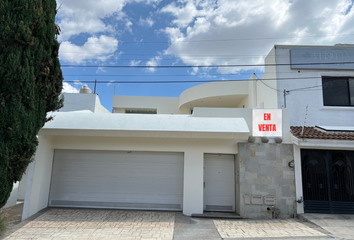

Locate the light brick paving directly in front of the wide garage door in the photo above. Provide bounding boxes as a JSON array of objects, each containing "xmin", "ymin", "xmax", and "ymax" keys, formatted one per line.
[{"xmin": 5, "ymin": 209, "xmax": 175, "ymax": 240}]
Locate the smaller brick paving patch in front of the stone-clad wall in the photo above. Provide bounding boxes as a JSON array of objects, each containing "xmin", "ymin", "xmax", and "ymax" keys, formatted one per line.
[{"xmin": 214, "ymin": 219, "xmax": 327, "ymax": 239}]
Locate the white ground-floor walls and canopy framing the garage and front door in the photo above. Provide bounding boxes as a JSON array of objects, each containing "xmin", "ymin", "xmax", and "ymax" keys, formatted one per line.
[{"xmin": 23, "ymin": 104, "xmax": 290, "ymax": 219}]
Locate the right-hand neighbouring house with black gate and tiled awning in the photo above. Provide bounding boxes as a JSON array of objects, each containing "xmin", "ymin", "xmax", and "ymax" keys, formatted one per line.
[{"xmin": 261, "ymin": 44, "xmax": 354, "ymax": 214}]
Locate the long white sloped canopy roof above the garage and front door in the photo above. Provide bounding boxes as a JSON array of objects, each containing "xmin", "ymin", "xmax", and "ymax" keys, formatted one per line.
[{"xmin": 39, "ymin": 112, "xmax": 250, "ymax": 139}]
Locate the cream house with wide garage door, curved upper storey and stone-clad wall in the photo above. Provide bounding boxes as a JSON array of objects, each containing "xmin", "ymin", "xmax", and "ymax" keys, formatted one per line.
[{"xmin": 23, "ymin": 76, "xmax": 295, "ymax": 219}]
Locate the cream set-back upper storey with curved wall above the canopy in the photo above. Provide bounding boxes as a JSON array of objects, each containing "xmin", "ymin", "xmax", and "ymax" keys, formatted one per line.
[{"xmin": 112, "ymin": 75, "xmax": 277, "ymax": 114}]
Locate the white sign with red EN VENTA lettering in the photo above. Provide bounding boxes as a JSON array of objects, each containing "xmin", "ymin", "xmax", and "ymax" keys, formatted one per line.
[{"xmin": 252, "ymin": 109, "xmax": 283, "ymax": 137}]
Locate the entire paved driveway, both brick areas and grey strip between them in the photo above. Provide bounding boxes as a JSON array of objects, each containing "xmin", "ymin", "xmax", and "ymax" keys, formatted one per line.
[{"xmin": 1, "ymin": 208, "xmax": 327, "ymax": 240}]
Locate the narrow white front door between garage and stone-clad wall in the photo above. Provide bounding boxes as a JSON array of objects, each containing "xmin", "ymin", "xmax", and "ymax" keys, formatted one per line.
[{"xmin": 204, "ymin": 154, "xmax": 235, "ymax": 212}]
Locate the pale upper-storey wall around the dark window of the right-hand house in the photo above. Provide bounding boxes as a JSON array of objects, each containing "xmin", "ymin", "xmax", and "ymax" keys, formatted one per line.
[{"xmin": 261, "ymin": 45, "xmax": 354, "ymax": 126}]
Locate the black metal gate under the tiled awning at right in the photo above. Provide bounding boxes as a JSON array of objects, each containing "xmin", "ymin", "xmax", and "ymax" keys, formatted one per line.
[{"xmin": 301, "ymin": 149, "xmax": 354, "ymax": 214}]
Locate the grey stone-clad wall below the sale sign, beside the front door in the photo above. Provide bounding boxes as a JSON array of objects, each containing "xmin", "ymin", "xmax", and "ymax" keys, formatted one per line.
[{"xmin": 236, "ymin": 143, "xmax": 296, "ymax": 218}]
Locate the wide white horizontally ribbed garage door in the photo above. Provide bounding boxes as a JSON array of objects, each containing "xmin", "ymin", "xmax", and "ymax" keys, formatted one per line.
[{"xmin": 49, "ymin": 150, "xmax": 183, "ymax": 210}]
